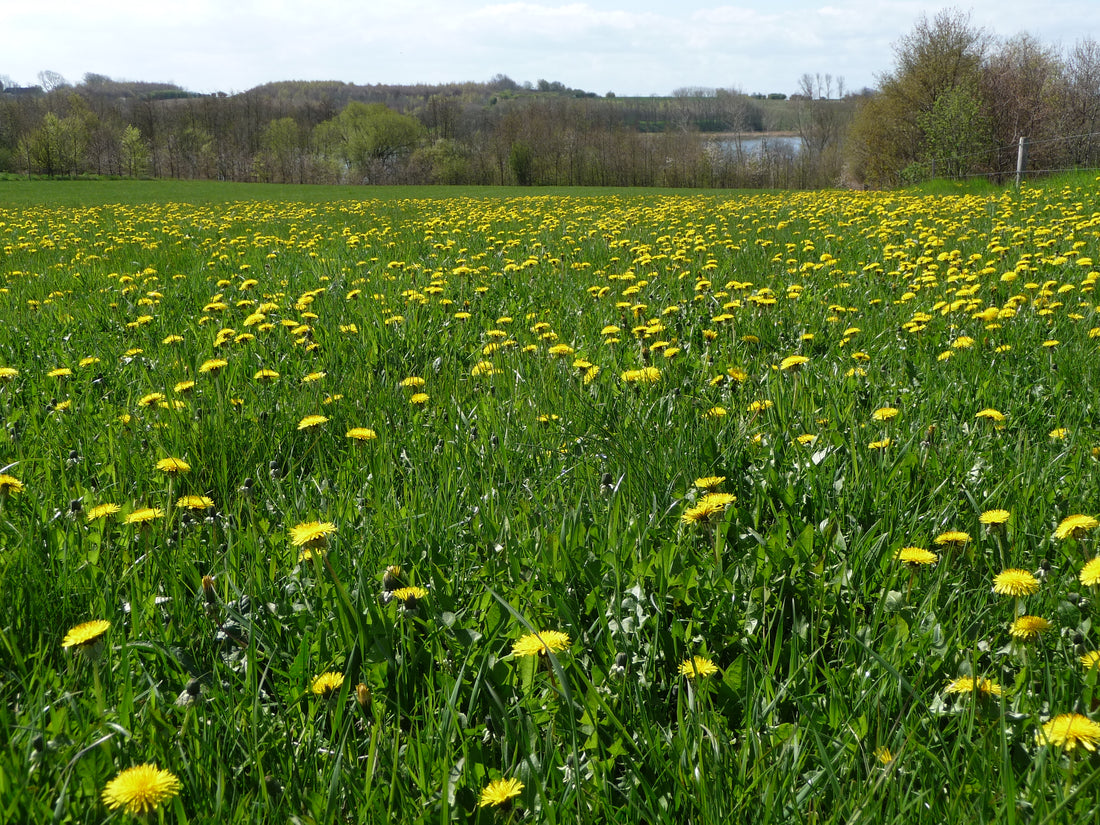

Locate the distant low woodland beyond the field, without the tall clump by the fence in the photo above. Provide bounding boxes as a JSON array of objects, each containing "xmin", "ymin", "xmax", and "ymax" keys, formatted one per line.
[{"xmin": 0, "ymin": 73, "xmax": 850, "ymax": 187}]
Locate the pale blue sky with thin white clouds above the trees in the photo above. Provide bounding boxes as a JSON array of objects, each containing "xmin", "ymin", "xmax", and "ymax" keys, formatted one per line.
[{"xmin": 0, "ymin": 0, "xmax": 1100, "ymax": 96}]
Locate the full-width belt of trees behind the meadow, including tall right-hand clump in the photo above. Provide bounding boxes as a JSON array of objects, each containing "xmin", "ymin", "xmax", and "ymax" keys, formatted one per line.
[{"xmin": 0, "ymin": 9, "xmax": 1100, "ymax": 188}]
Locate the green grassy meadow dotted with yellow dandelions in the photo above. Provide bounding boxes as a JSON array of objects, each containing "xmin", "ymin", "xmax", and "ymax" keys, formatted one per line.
[{"xmin": 0, "ymin": 177, "xmax": 1100, "ymax": 823}]
